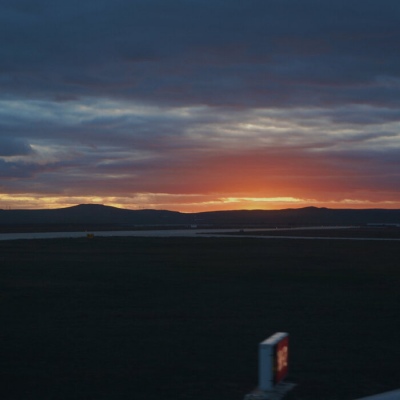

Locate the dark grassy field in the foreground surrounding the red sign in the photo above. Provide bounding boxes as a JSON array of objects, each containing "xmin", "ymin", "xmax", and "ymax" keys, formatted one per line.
[{"xmin": 0, "ymin": 238, "xmax": 400, "ymax": 400}]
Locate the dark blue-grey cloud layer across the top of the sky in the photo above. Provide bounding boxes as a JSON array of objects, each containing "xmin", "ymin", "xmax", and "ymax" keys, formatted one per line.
[{"xmin": 0, "ymin": 0, "xmax": 400, "ymax": 107}]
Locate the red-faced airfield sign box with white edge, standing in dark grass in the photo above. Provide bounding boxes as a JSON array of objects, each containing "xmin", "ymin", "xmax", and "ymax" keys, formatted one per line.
[{"xmin": 259, "ymin": 332, "xmax": 289, "ymax": 391}]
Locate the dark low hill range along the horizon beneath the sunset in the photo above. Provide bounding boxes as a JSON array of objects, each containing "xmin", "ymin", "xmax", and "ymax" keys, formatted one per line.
[{"xmin": 0, "ymin": 204, "xmax": 400, "ymax": 230}]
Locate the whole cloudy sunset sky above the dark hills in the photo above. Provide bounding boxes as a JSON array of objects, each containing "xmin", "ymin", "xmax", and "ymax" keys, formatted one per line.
[{"xmin": 0, "ymin": 0, "xmax": 400, "ymax": 212}]
